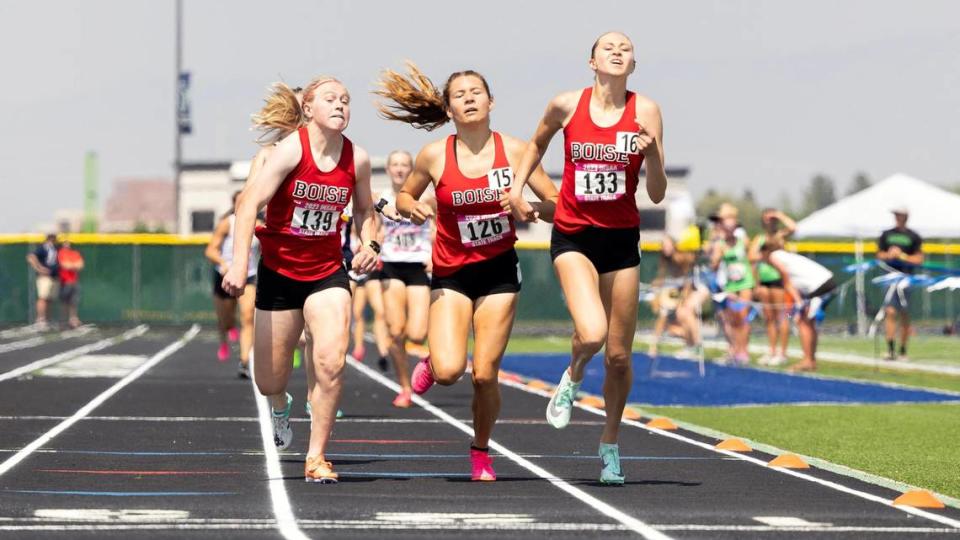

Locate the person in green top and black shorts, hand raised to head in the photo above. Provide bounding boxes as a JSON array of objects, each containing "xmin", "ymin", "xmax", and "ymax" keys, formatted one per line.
[{"xmin": 750, "ymin": 208, "xmax": 797, "ymax": 366}]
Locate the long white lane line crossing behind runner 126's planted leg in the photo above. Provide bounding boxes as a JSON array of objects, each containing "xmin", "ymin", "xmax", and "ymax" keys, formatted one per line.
[{"xmin": 347, "ymin": 356, "xmax": 670, "ymax": 540}]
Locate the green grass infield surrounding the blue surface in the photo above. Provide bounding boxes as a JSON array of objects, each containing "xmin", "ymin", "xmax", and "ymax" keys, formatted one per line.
[{"xmin": 498, "ymin": 336, "xmax": 960, "ymax": 498}]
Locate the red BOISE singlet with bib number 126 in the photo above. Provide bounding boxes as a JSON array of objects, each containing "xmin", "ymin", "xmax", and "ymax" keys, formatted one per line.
[{"xmin": 433, "ymin": 131, "xmax": 517, "ymax": 277}]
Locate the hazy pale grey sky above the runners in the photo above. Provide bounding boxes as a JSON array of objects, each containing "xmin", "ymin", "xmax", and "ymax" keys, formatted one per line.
[{"xmin": 0, "ymin": 0, "xmax": 960, "ymax": 232}]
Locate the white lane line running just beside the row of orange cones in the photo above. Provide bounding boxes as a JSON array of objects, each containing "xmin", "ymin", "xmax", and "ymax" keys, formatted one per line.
[{"xmin": 500, "ymin": 381, "xmax": 960, "ymax": 529}]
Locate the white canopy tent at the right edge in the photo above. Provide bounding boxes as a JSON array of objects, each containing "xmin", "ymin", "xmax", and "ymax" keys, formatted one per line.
[{"xmin": 795, "ymin": 174, "xmax": 960, "ymax": 334}]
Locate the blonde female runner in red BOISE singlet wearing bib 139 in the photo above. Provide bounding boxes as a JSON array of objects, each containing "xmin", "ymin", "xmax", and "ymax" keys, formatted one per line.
[{"xmin": 223, "ymin": 77, "xmax": 379, "ymax": 483}]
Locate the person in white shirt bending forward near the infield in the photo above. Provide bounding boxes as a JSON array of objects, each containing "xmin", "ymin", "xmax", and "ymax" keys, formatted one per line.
[{"xmin": 760, "ymin": 243, "xmax": 837, "ymax": 371}]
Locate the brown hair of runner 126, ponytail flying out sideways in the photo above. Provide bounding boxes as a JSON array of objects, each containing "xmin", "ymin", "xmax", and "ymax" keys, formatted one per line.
[{"xmin": 373, "ymin": 61, "xmax": 493, "ymax": 131}]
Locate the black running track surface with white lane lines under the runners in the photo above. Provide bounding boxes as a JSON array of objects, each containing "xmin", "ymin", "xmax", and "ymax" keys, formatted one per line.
[{"xmin": 0, "ymin": 328, "xmax": 960, "ymax": 540}]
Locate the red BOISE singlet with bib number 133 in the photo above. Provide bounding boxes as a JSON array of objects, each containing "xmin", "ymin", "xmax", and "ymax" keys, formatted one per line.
[{"xmin": 553, "ymin": 88, "xmax": 643, "ymax": 234}]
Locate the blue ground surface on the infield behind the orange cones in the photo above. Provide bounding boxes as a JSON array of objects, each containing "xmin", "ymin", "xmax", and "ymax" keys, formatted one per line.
[{"xmin": 501, "ymin": 353, "xmax": 960, "ymax": 406}]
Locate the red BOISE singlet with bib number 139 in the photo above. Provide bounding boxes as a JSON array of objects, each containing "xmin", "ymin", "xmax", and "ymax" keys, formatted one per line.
[{"xmin": 257, "ymin": 127, "xmax": 357, "ymax": 281}]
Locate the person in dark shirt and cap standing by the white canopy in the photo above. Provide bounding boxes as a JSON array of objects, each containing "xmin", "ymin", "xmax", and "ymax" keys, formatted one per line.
[{"xmin": 877, "ymin": 206, "xmax": 924, "ymax": 360}]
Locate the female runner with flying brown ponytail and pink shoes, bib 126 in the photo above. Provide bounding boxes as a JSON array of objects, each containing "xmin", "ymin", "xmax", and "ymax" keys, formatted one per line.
[{"xmin": 377, "ymin": 64, "xmax": 557, "ymax": 481}]
